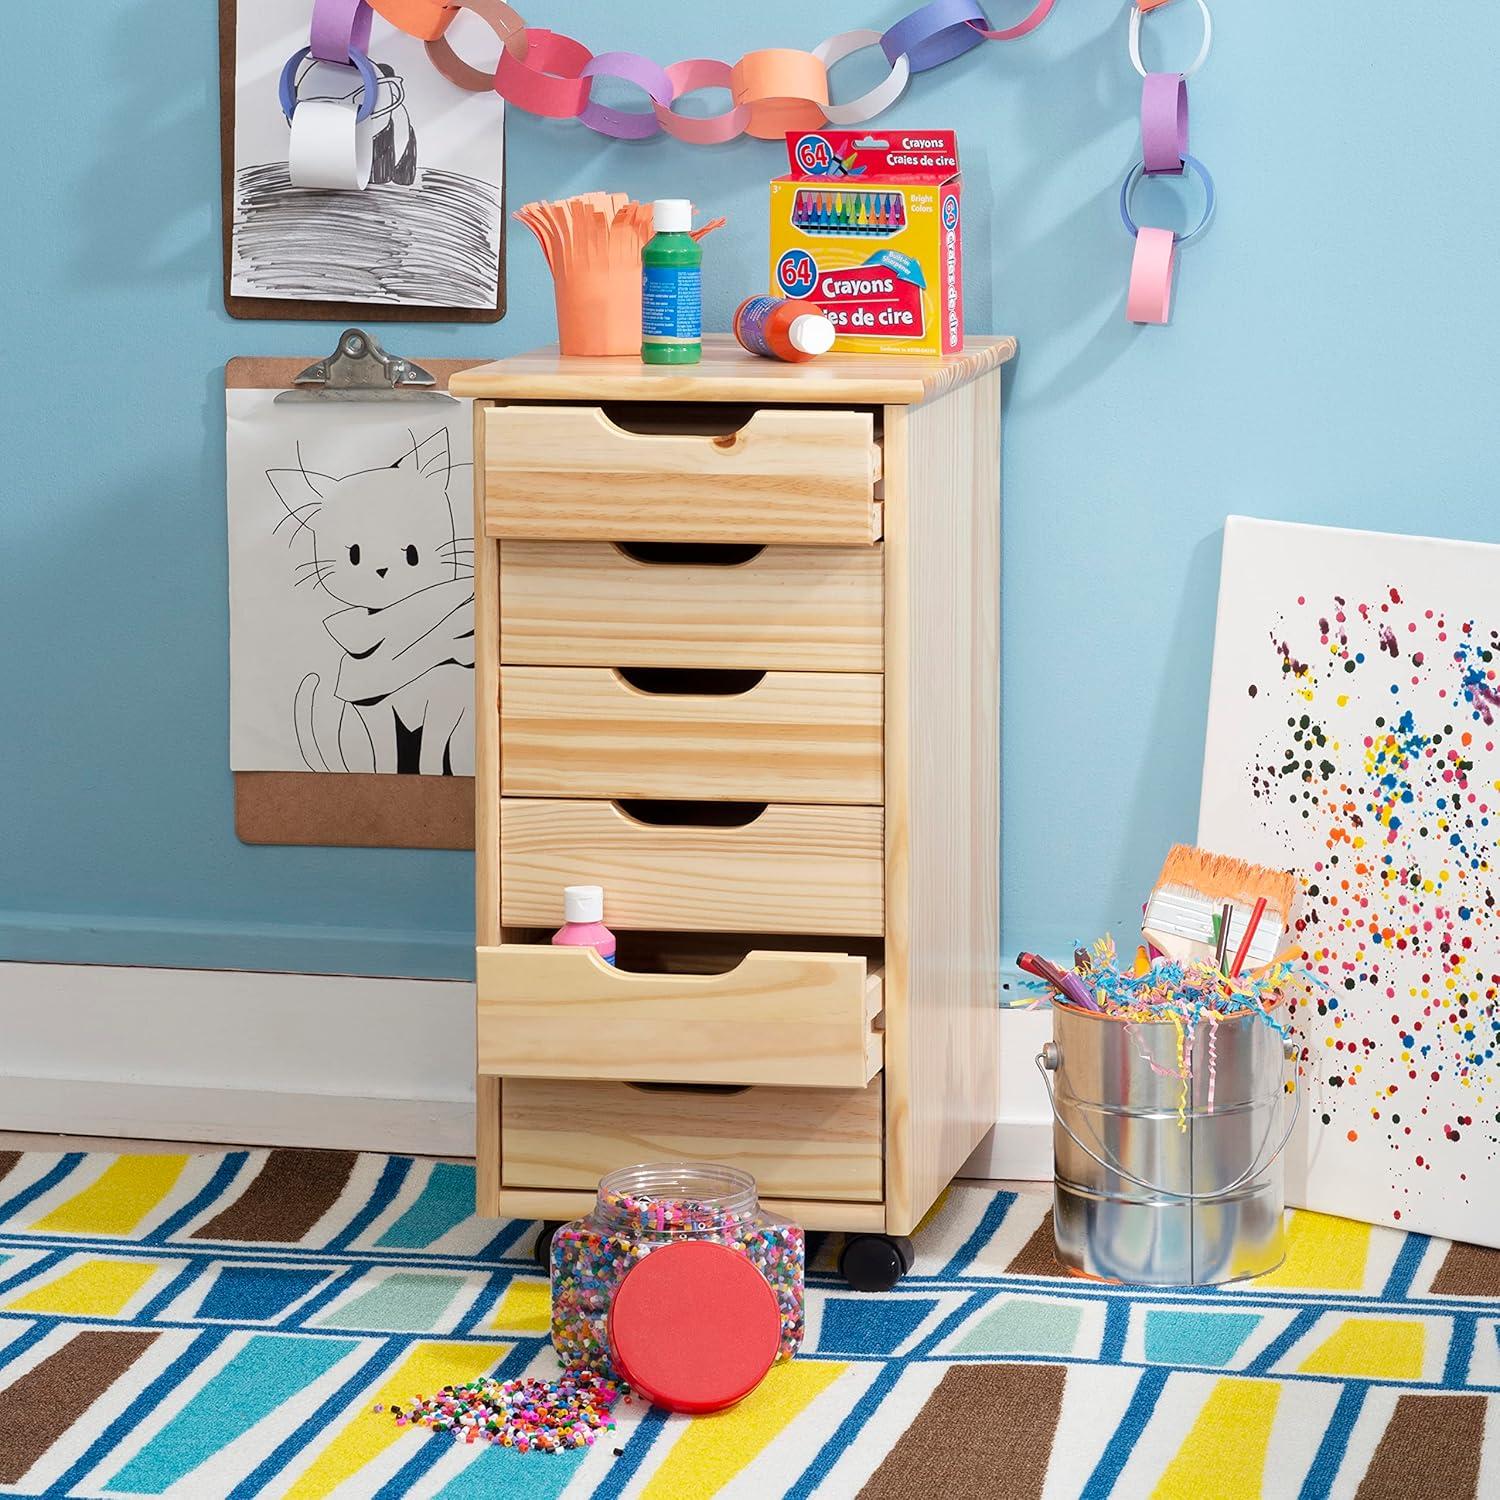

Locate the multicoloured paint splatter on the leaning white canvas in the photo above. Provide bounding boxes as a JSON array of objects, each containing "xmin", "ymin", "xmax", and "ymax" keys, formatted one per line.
[{"xmin": 1247, "ymin": 584, "xmax": 1500, "ymax": 1220}]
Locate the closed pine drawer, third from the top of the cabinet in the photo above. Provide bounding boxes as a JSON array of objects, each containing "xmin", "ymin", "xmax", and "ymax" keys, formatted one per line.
[{"xmin": 500, "ymin": 666, "xmax": 885, "ymax": 806}]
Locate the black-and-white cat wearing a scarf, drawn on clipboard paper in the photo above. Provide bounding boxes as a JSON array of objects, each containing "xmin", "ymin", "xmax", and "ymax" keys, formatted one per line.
[{"xmin": 266, "ymin": 428, "xmax": 474, "ymax": 776}]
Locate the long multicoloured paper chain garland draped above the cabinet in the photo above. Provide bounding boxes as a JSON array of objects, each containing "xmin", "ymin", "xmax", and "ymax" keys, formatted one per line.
[{"xmin": 281, "ymin": 0, "xmax": 1056, "ymax": 147}]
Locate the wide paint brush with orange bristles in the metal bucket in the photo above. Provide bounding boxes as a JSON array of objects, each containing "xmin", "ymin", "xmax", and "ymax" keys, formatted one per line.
[{"xmin": 1140, "ymin": 845, "xmax": 1298, "ymax": 971}]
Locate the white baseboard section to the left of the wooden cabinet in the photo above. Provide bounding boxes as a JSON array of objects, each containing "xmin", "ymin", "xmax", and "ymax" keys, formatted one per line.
[{"xmin": 0, "ymin": 963, "xmax": 474, "ymax": 1157}]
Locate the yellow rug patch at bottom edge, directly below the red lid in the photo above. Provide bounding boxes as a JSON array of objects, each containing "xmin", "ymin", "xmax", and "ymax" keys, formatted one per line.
[{"xmin": 641, "ymin": 1359, "xmax": 849, "ymax": 1500}]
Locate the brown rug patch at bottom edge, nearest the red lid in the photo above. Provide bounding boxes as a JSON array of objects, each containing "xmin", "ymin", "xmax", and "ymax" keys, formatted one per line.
[{"xmin": 860, "ymin": 1365, "xmax": 1068, "ymax": 1500}]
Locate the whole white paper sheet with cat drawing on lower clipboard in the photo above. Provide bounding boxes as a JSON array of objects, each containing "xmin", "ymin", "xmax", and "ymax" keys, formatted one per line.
[{"xmin": 225, "ymin": 390, "xmax": 474, "ymax": 776}]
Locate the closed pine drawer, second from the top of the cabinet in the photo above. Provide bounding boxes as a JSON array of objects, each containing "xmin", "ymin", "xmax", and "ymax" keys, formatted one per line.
[{"xmin": 500, "ymin": 542, "xmax": 884, "ymax": 672}]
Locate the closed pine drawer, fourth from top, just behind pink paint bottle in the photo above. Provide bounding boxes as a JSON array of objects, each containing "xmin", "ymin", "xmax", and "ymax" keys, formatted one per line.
[{"xmin": 500, "ymin": 797, "xmax": 885, "ymax": 936}]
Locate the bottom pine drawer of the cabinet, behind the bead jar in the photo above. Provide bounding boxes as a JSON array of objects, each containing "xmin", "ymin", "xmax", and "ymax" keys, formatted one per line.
[{"xmin": 500, "ymin": 1079, "xmax": 882, "ymax": 1203}]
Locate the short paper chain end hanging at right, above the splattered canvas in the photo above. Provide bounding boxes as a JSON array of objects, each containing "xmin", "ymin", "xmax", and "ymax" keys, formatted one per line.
[{"xmin": 1121, "ymin": 0, "xmax": 1214, "ymax": 324}]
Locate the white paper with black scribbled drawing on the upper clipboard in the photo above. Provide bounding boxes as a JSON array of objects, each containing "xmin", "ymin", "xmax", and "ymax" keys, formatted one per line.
[{"xmin": 230, "ymin": 0, "xmax": 506, "ymax": 308}]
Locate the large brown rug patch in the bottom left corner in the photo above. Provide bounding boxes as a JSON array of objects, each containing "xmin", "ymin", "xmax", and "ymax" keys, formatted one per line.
[{"xmin": 0, "ymin": 1329, "xmax": 158, "ymax": 1485}]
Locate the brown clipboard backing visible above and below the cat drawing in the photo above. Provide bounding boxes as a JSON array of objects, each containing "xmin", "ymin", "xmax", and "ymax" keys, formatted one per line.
[{"xmin": 224, "ymin": 359, "xmax": 483, "ymax": 849}]
